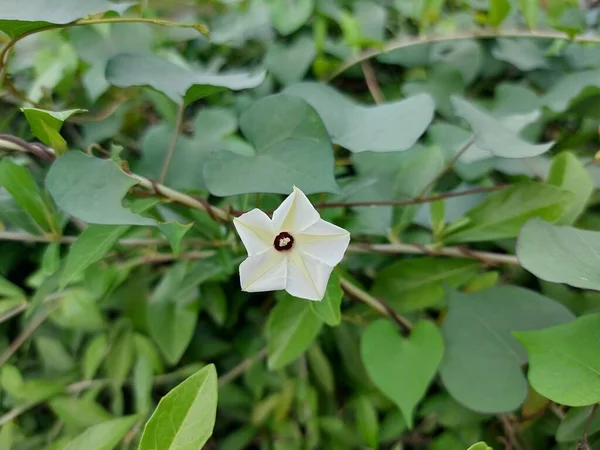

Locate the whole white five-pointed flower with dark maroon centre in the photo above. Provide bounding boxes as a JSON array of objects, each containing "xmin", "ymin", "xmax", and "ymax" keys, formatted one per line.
[{"xmin": 233, "ymin": 186, "xmax": 350, "ymax": 300}]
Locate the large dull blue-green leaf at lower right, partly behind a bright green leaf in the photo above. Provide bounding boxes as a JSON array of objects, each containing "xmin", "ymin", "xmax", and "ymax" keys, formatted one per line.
[{"xmin": 440, "ymin": 286, "xmax": 573, "ymax": 413}]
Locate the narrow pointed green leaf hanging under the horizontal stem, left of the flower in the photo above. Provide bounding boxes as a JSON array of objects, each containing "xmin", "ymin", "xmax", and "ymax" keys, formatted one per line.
[{"xmin": 59, "ymin": 225, "xmax": 129, "ymax": 289}]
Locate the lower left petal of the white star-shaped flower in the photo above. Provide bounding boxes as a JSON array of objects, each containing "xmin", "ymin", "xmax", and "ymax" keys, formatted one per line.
[{"xmin": 240, "ymin": 248, "xmax": 288, "ymax": 292}]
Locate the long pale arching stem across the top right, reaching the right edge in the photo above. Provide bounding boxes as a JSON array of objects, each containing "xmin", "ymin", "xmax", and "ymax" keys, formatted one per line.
[{"xmin": 324, "ymin": 30, "xmax": 600, "ymax": 81}]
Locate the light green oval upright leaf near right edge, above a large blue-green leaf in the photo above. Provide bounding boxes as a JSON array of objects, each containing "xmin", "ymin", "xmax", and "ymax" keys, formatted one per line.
[{"xmin": 547, "ymin": 152, "xmax": 595, "ymax": 225}]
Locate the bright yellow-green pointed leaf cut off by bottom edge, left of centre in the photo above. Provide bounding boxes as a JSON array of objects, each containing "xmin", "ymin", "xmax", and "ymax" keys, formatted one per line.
[{"xmin": 139, "ymin": 364, "xmax": 217, "ymax": 450}]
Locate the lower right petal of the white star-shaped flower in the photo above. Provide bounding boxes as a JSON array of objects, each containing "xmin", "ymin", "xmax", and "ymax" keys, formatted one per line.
[{"xmin": 285, "ymin": 251, "xmax": 333, "ymax": 300}]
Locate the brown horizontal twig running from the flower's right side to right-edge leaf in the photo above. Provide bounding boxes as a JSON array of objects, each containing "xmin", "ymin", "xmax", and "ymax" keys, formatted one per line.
[{"xmin": 348, "ymin": 243, "xmax": 520, "ymax": 266}]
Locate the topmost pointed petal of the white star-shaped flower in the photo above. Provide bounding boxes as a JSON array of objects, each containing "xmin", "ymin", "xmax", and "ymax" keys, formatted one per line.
[{"xmin": 273, "ymin": 186, "xmax": 320, "ymax": 236}]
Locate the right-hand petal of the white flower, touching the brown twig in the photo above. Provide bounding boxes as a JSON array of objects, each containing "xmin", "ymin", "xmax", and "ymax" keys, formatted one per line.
[{"xmin": 295, "ymin": 219, "xmax": 350, "ymax": 267}]
